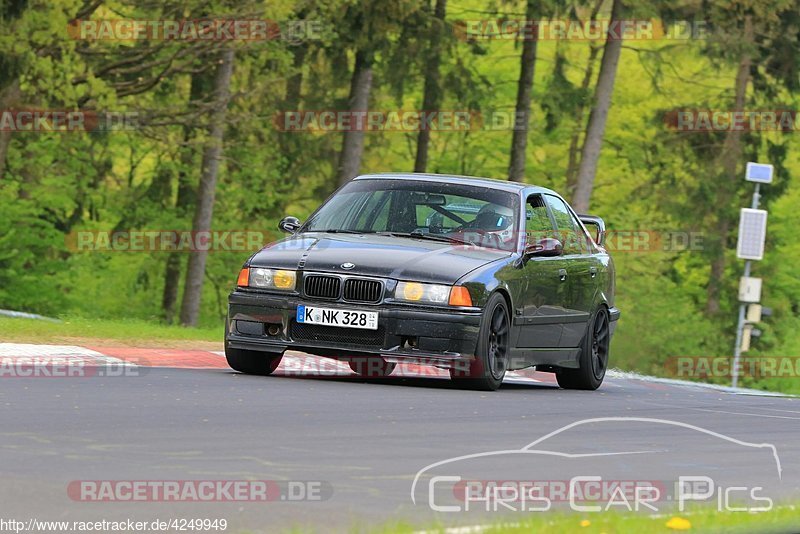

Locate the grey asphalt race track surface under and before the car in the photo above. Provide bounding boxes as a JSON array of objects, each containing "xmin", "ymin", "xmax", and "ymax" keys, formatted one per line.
[{"xmin": 0, "ymin": 351, "xmax": 800, "ymax": 532}]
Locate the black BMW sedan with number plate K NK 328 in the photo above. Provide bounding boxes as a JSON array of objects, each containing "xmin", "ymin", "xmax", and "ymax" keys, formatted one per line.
[{"xmin": 225, "ymin": 174, "xmax": 619, "ymax": 390}]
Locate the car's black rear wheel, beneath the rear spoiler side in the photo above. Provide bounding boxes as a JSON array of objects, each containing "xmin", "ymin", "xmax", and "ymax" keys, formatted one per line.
[{"xmin": 556, "ymin": 306, "xmax": 611, "ymax": 390}]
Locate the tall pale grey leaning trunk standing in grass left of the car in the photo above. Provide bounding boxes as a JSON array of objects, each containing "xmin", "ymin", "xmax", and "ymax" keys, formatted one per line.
[{"xmin": 181, "ymin": 49, "xmax": 234, "ymax": 326}]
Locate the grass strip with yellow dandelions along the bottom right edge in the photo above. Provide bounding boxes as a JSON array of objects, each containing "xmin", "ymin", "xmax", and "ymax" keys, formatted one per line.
[{"xmin": 369, "ymin": 505, "xmax": 800, "ymax": 534}]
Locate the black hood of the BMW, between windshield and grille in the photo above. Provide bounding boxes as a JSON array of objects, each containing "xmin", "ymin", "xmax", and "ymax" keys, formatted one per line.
[{"xmin": 250, "ymin": 233, "xmax": 511, "ymax": 284}]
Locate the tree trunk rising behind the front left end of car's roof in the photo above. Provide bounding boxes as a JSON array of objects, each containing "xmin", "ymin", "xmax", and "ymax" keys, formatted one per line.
[{"xmin": 338, "ymin": 50, "xmax": 372, "ymax": 185}]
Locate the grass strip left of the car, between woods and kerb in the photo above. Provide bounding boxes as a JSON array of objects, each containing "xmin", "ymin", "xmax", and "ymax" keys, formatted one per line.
[{"xmin": 0, "ymin": 317, "xmax": 224, "ymax": 345}]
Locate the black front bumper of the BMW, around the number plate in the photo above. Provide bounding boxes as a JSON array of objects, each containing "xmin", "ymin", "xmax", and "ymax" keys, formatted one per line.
[{"xmin": 225, "ymin": 290, "xmax": 481, "ymax": 367}]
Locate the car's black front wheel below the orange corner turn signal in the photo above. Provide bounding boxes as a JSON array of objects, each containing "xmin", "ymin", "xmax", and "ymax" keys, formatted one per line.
[{"xmin": 450, "ymin": 293, "xmax": 511, "ymax": 391}]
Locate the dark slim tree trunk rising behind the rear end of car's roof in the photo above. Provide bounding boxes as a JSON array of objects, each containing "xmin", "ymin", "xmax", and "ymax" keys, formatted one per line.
[{"xmin": 508, "ymin": 0, "xmax": 540, "ymax": 182}]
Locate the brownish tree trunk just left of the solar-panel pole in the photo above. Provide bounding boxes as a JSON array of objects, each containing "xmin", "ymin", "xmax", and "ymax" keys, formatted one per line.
[{"xmin": 706, "ymin": 15, "xmax": 753, "ymax": 315}]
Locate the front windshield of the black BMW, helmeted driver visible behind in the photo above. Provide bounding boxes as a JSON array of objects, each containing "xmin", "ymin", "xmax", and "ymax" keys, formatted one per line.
[{"xmin": 303, "ymin": 179, "xmax": 519, "ymax": 250}]
